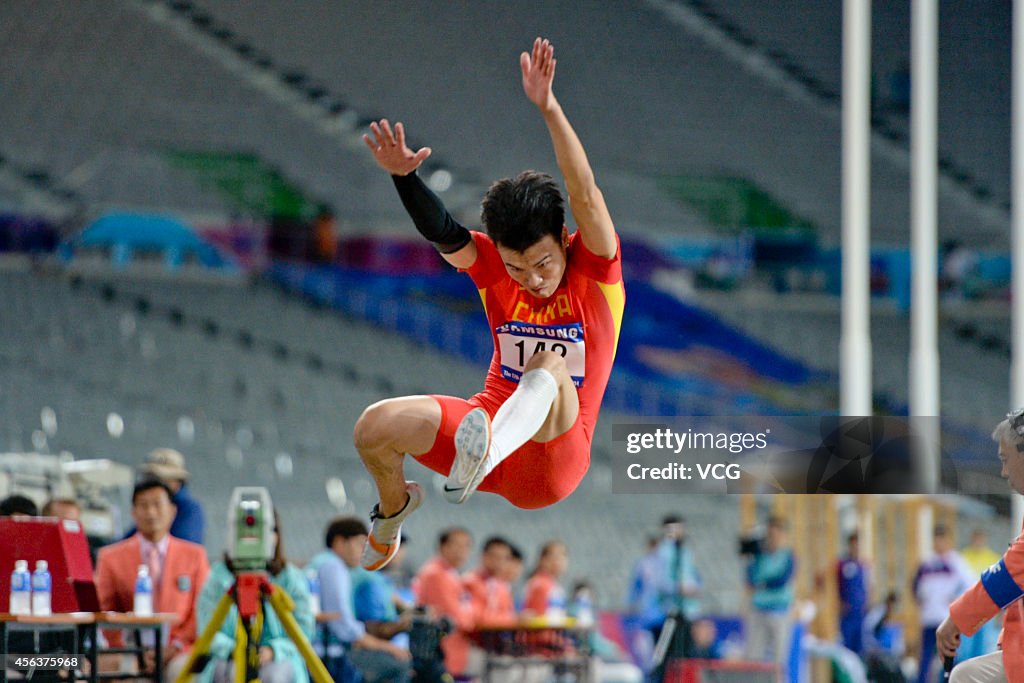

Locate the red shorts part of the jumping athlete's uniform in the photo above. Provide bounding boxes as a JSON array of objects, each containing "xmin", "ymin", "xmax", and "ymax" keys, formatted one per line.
[{"xmin": 416, "ymin": 395, "xmax": 590, "ymax": 510}]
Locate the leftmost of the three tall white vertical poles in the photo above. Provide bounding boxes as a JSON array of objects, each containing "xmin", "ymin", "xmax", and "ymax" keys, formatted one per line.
[{"xmin": 840, "ymin": 0, "xmax": 871, "ymax": 416}]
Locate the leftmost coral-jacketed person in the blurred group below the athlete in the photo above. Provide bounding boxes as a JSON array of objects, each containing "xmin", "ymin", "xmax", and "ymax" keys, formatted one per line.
[{"xmin": 413, "ymin": 527, "xmax": 476, "ymax": 676}]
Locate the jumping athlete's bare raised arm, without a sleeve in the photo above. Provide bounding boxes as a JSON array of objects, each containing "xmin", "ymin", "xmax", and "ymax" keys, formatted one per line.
[{"xmin": 519, "ymin": 38, "xmax": 616, "ymax": 258}]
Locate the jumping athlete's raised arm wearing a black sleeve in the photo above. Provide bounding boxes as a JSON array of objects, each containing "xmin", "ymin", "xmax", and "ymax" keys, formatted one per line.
[{"xmin": 362, "ymin": 119, "xmax": 476, "ymax": 268}]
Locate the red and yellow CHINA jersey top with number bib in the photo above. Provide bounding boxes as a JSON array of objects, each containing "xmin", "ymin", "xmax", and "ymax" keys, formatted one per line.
[{"xmin": 466, "ymin": 231, "xmax": 626, "ymax": 442}]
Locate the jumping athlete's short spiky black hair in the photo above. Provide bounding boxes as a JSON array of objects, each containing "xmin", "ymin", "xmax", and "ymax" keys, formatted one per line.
[{"xmin": 480, "ymin": 171, "xmax": 565, "ymax": 253}]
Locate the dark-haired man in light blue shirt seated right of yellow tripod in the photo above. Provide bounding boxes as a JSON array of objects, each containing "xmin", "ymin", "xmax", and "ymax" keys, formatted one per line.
[{"xmin": 307, "ymin": 517, "xmax": 410, "ymax": 683}]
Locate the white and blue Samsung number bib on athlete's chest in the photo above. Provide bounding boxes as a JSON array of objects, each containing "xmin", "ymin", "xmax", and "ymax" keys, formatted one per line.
[{"xmin": 495, "ymin": 323, "xmax": 587, "ymax": 387}]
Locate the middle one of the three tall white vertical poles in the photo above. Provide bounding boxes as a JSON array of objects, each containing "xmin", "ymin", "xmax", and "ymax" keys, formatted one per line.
[{"xmin": 909, "ymin": 0, "xmax": 941, "ymax": 493}]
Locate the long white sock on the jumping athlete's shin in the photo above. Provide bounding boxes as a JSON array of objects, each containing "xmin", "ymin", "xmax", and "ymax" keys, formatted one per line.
[{"xmin": 483, "ymin": 368, "xmax": 558, "ymax": 472}]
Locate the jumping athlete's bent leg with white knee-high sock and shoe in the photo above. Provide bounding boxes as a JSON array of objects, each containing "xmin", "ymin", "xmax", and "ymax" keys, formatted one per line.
[{"xmin": 444, "ymin": 351, "xmax": 580, "ymax": 503}]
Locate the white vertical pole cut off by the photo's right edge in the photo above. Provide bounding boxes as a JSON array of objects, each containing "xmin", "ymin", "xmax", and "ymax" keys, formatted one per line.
[{"xmin": 1010, "ymin": 0, "xmax": 1024, "ymax": 528}]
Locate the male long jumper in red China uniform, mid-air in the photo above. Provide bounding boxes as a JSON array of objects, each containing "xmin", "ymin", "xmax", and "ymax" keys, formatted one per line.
[{"xmin": 355, "ymin": 38, "xmax": 626, "ymax": 569}]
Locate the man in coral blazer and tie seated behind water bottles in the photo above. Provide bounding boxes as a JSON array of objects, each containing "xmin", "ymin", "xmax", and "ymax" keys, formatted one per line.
[{"xmin": 96, "ymin": 479, "xmax": 210, "ymax": 680}]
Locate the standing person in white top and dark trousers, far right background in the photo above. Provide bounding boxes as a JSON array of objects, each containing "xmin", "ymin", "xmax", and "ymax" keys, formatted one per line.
[{"xmin": 913, "ymin": 524, "xmax": 975, "ymax": 683}]
